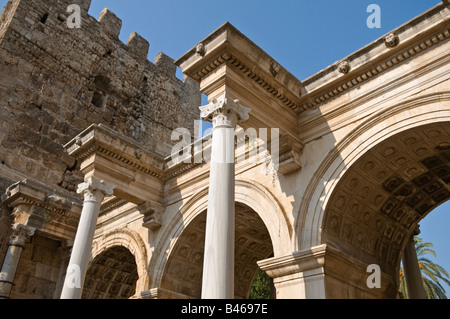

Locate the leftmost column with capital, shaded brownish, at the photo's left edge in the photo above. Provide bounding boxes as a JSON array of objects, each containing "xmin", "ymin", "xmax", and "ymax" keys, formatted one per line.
[{"xmin": 0, "ymin": 224, "xmax": 35, "ymax": 299}]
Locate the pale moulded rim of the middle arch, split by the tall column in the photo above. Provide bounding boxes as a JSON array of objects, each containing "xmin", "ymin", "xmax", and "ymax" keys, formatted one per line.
[{"xmin": 149, "ymin": 180, "xmax": 292, "ymax": 297}]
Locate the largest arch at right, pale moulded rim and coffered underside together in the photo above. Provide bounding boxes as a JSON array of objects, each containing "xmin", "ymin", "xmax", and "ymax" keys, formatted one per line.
[{"xmin": 297, "ymin": 92, "xmax": 450, "ymax": 297}]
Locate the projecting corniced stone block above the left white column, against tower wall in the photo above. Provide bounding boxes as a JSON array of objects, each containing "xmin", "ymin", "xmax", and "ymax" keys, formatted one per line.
[{"xmin": 65, "ymin": 124, "xmax": 165, "ymax": 205}]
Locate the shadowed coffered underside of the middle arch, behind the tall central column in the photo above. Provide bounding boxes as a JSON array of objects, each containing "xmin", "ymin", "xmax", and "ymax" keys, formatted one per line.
[{"xmin": 161, "ymin": 203, "xmax": 273, "ymax": 299}]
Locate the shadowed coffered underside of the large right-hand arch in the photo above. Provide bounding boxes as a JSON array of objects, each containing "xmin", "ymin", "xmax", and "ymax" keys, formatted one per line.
[{"xmin": 322, "ymin": 122, "xmax": 450, "ymax": 276}]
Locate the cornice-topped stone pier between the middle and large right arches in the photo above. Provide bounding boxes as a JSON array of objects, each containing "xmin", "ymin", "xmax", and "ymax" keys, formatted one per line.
[{"xmin": 258, "ymin": 245, "xmax": 397, "ymax": 299}]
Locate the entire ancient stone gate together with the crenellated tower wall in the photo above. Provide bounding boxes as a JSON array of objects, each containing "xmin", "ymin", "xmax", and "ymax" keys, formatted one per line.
[{"xmin": 0, "ymin": 0, "xmax": 450, "ymax": 299}]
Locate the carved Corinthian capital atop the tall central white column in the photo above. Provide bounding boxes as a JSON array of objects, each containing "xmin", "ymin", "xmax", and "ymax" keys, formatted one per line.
[{"xmin": 200, "ymin": 94, "xmax": 251, "ymax": 128}]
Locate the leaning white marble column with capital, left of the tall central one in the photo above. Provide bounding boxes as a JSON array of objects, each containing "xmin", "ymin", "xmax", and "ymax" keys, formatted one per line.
[{"xmin": 61, "ymin": 177, "xmax": 114, "ymax": 299}]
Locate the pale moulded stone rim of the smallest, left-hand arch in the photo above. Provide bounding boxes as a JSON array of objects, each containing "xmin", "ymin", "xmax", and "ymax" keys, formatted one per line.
[{"xmin": 90, "ymin": 228, "xmax": 148, "ymax": 292}]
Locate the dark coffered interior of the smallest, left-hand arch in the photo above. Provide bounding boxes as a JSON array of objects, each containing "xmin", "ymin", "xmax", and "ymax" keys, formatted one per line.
[{"xmin": 82, "ymin": 246, "xmax": 139, "ymax": 299}]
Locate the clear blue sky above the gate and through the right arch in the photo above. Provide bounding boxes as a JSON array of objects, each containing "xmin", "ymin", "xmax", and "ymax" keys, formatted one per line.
[{"xmin": 0, "ymin": 0, "xmax": 450, "ymax": 296}]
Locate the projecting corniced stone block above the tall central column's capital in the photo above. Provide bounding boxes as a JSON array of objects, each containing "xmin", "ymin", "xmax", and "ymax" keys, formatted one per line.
[{"xmin": 175, "ymin": 22, "xmax": 304, "ymax": 139}]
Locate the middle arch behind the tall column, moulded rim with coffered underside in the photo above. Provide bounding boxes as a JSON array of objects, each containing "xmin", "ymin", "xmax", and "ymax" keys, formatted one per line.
[{"xmin": 148, "ymin": 179, "xmax": 292, "ymax": 298}]
